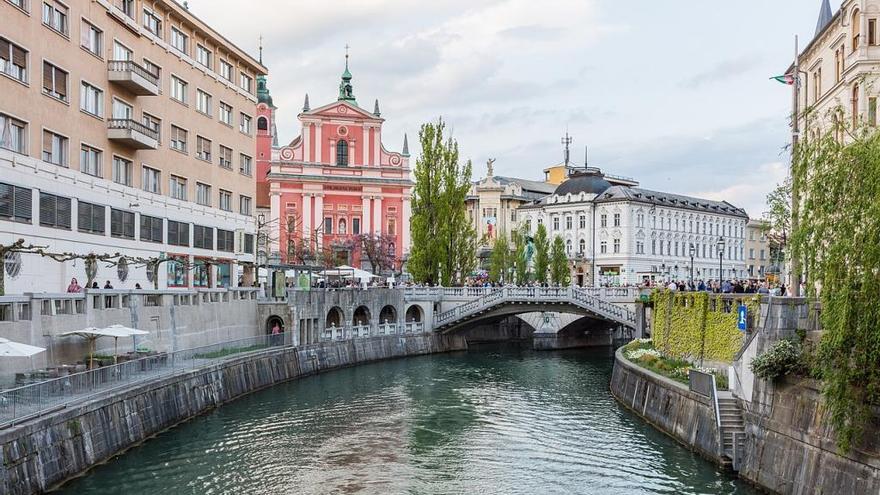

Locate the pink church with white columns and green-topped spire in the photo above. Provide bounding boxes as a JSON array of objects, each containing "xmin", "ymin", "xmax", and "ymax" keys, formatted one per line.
[{"xmin": 256, "ymin": 55, "xmax": 413, "ymax": 270}]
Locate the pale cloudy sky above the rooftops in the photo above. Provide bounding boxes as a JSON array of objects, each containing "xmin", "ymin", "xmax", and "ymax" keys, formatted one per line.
[{"xmin": 189, "ymin": 0, "xmax": 828, "ymax": 216}]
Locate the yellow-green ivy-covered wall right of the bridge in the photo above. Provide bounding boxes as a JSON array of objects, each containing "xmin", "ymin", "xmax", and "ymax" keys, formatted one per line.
[{"xmin": 651, "ymin": 290, "xmax": 760, "ymax": 362}]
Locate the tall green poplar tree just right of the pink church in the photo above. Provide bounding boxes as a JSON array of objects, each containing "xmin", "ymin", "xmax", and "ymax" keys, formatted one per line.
[{"xmin": 407, "ymin": 119, "xmax": 476, "ymax": 285}]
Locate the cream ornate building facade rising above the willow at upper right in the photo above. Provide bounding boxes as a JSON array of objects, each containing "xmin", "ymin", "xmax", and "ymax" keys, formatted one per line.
[{"xmin": 788, "ymin": 0, "xmax": 880, "ymax": 134}]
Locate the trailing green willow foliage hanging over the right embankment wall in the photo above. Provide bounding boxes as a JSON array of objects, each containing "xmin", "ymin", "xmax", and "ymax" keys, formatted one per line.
[{"xmin": 791, "ymin": 113, "xmax": 880, "ymax": 452}]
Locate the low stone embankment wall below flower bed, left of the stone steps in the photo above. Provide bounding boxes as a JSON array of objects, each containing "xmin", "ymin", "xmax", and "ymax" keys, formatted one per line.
[{"xmin": 611, "ymin": 348, "xmax": 723, "ymax": 464}]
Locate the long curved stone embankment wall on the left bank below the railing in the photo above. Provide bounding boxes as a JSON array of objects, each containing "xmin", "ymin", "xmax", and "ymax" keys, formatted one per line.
[{"xmin": 0, "ymin": 334, "xmax": 467, "ymax": 495}]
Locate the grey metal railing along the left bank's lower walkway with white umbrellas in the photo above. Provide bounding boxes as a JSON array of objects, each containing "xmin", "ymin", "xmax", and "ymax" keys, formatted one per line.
[{"xmin": 0, "ymin": 334, "xmax": 287, "ymax": 427}]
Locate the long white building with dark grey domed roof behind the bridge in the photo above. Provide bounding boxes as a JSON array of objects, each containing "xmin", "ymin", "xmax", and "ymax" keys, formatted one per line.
[{"xmin": 518, "ymin": 168, "xmax": 748, "ymax": 285}]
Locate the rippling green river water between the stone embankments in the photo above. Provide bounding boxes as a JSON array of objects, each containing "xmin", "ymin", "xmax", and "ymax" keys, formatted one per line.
[{"xmin": 61, "ymin": 347, "xmax": 756, "ymax": 495}]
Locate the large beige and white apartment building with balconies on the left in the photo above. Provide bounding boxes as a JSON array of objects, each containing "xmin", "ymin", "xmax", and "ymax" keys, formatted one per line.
[{"xmin": 0, "ymin": 0, "xmax": 266, "ymax": 293}]
